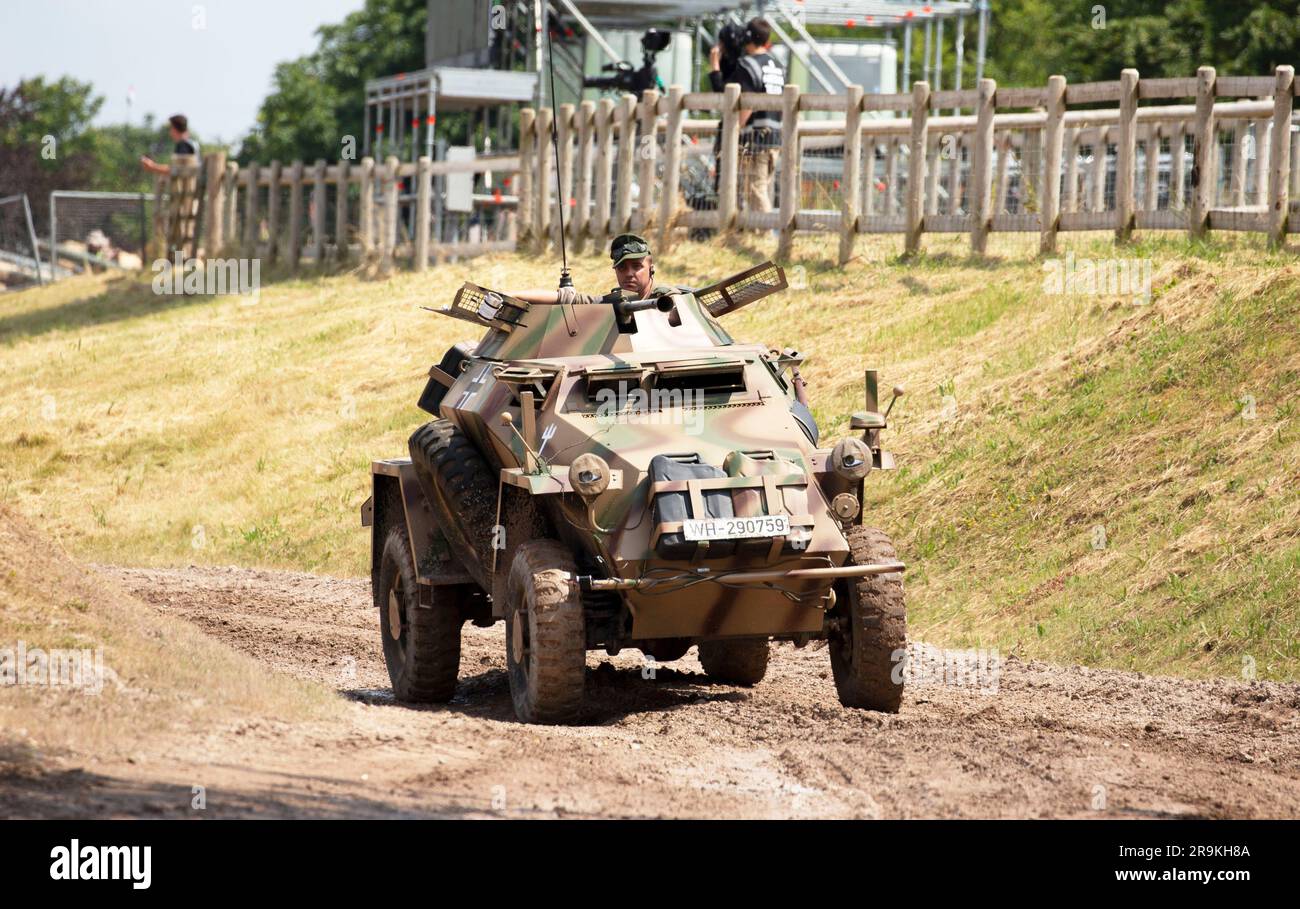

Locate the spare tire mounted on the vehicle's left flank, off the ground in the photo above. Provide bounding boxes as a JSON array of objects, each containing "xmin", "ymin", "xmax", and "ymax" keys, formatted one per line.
[{"xmin": 410, "ymin": 420, "xmax": 497, "ymax": 593}]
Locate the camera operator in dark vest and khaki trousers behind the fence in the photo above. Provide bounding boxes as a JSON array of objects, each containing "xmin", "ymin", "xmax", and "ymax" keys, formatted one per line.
[{"xmin": 735, "ymin": 18, "xmax": 785, "ymax": 212}]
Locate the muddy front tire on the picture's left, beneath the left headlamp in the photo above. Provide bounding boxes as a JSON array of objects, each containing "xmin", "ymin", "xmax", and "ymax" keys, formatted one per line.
[{"xmin": 506, "ymin": 540, "xmax": 586, "ymax": 723}]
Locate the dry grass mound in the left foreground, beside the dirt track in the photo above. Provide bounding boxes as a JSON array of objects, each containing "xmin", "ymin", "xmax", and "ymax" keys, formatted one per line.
[{"xmin": 0, "ymin": 506, "xmax": 333, "ymax": 765}]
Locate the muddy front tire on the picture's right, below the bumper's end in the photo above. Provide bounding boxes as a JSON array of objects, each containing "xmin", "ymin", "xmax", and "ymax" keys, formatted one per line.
[{"xmin": 828, "ymin": 527, "xmax": 907, "ymax": 713}]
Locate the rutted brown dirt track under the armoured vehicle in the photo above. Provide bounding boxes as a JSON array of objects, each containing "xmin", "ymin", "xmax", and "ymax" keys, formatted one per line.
[{"xmin": 13, "ymin": 568, "xmax": 1300, "ymax": 818}]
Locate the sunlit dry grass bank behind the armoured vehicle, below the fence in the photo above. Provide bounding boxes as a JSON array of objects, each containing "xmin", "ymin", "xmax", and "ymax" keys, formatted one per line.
[{"xmin": 0, "ymin": 237, "xmax": 1300, "ymax": 678}]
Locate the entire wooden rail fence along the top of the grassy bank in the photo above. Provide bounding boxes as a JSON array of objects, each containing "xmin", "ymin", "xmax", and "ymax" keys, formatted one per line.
[{"xmin": 159, "ymin": 66, "xmax": 1300, "ymax": 270}]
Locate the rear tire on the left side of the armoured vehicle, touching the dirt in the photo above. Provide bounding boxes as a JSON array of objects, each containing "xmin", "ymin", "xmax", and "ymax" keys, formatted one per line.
[{"xmin": 374, "ymin": 527, "xmax": 464, "ymax": 704}]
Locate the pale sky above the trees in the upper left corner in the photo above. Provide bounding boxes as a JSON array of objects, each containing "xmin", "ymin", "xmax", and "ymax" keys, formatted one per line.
[{"xmin": 0, "ymin": 0, "xmax": 364, "ymax": 142}]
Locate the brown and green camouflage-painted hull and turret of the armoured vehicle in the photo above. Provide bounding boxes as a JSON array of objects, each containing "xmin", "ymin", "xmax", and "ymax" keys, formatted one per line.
[{"xmin": 374, "ymin": 270, "xmax": 892, "ymax": 646}]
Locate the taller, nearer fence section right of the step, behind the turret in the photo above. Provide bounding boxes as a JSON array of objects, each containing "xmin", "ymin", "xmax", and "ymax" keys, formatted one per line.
[{"xmin": 519, "ymin": 66, "xmax": 1300, "ymax": 261}]
